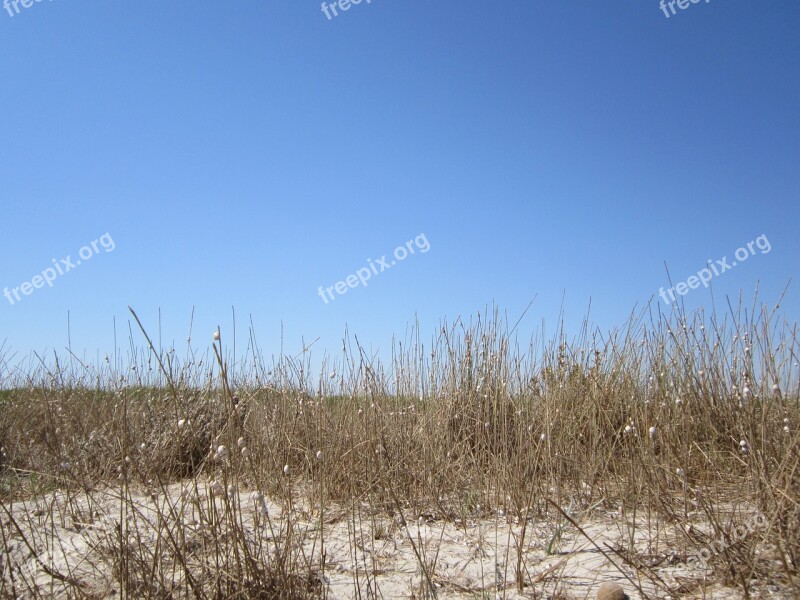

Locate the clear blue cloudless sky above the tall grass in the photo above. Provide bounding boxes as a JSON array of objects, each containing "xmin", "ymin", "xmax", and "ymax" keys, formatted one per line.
[{"xmin": 0, "ymin": 0, "xmax": 800, "ymax": 372}]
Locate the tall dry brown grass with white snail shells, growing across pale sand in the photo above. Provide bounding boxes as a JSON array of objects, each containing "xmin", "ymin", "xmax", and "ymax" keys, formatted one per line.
[{"xmin": 0, "ymin": 307, "xmax": 800, "ymax": 598}]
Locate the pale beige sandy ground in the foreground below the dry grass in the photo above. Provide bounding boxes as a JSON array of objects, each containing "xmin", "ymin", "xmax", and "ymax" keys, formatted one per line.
[{"xmin": 0, "ymin": 484, "xmax": 793, "ymax": 599}]
